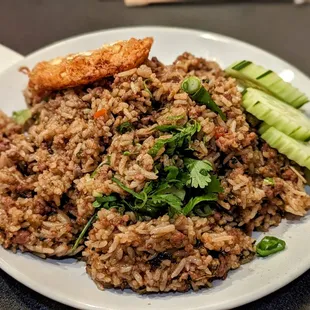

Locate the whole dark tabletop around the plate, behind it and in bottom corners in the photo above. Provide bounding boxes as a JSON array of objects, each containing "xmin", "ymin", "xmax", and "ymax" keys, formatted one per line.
[{"xmin": 0, "ymin": 0, "xmax": 310, "ymax": 310}]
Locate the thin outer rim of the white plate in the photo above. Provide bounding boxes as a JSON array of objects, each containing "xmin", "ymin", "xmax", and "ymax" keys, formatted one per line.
[{"xmin": 0, "ymin": 25, "xmax": 310, "ymax": 310}]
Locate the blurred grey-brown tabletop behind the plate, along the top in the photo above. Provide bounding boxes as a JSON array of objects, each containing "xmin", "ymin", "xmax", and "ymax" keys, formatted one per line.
[{"xmin": 0, "ymin": 0, "xmax": 310, "ymax": 74}]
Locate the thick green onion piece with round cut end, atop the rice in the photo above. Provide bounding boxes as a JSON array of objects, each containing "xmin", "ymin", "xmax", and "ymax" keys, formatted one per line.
[{"xmin": 181, "ymin": 76, "xmax": 226, "ymax": 121}]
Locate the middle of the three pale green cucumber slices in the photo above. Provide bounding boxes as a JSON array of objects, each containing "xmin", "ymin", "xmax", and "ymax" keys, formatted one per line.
[{"xmin": 243, "ymin": 88, "xmax": 310, "ymax": 141}]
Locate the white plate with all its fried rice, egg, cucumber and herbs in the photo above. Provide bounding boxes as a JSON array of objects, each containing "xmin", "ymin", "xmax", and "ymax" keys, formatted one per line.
[{"xmin": 0, "ymin": 27, "xmax": 310, "ymax": 310}]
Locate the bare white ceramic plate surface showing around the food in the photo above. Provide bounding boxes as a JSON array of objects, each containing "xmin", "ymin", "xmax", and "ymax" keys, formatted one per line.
[{"xmin": 0, "ymin": 27, "xmax": 310, "ymax": 310}]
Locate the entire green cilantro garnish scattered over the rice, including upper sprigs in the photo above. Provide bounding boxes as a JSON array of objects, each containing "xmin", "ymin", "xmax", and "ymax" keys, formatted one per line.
[{"xmin": 74, "ymin": 121, "xmax": 223, "ymax": 249}]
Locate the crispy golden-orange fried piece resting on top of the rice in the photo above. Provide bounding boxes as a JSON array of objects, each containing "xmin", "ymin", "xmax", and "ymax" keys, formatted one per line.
[{"xmin": 28, "ymin": 38, "xmax": 153, "ymax": 94}]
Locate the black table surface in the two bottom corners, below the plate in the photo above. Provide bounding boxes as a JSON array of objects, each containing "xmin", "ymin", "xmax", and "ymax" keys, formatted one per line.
[{"xmin": 0, "ymin": 270, "xmax": 310, "ymax": 310}]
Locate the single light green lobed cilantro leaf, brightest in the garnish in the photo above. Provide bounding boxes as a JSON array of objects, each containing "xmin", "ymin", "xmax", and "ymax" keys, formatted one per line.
[{"xmin": 184, "ymin": 158, "xmax": 212, "ymax": 188}]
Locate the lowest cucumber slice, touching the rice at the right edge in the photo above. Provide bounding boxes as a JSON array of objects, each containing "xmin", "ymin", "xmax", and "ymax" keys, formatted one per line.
[{"xmin": 259, "ymin": 125, "xmax": 310, "ymax": 169}]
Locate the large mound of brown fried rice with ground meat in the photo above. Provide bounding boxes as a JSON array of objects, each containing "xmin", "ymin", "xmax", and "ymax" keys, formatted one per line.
[{"xmin": 0, "ymin": 46, "xmax": 310, "ymax": 293}]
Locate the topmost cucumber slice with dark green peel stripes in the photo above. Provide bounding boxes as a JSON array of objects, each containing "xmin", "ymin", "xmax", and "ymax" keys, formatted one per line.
[{"xmin": 225, "ymin": 60, "xmax": 309, "ymax": 108}]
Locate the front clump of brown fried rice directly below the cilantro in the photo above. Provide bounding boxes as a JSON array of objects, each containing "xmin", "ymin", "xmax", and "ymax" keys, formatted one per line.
[{"xmin": 83, "ymin": 210, "xmax": 254, "ymax": 293}]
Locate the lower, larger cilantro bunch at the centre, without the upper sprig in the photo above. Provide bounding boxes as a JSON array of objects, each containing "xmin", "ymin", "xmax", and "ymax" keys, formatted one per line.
[{"xmin": 93, "ymin": 158, "xmax": 222, "ymax": 218}]
